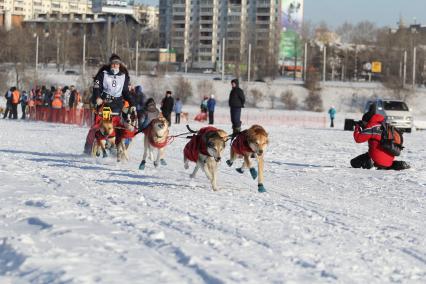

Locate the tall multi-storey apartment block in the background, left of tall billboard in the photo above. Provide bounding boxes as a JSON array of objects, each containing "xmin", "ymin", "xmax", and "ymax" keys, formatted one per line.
[{"xmin": 160, "ymin": 0, "xmax": 280, "ymax": 68}]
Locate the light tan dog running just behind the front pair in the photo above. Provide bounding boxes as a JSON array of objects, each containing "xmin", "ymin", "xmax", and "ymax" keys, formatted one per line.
[{"xmin": 139, "ymin": 116, "xmax": 169, "ymax": 170}]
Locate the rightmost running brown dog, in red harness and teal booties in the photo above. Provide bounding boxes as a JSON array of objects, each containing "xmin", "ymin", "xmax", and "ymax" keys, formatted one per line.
[{"xmin": 226, "ymin": 125, "xmax": 269, "ymax": 192}]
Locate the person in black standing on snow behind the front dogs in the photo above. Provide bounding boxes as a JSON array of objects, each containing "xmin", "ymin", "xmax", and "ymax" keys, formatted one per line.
[{"xmin": 229, "ymin": 79, "xmax": 246, "ymax": 138}]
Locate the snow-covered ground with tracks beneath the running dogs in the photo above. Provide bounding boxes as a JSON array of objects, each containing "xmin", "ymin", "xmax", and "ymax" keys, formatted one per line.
[{"xmin": 0, "ymin": 116, "xmax": 426, "ymax": 283}]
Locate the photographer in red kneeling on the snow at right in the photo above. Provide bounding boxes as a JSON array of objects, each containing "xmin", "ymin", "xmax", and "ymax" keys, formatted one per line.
[{"xmin": 351, "ymin": 108, "xmax": 410, "ymax": 170}]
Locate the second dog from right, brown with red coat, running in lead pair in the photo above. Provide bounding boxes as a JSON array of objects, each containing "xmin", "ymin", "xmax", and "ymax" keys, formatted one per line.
[{"xmin": 183, "ymin": 127, "xmax": 228, "ymax": 191}]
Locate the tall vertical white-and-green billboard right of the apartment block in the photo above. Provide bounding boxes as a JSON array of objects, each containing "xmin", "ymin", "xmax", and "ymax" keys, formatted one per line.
[{"xmin": 280, "ymin": 0, "xmax": 304, "ymax": 66}]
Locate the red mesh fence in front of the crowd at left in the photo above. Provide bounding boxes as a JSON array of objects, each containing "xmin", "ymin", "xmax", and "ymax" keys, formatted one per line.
[{"xmin": 29, "ymin": 106, "xmax": 94, "ymax": 126}]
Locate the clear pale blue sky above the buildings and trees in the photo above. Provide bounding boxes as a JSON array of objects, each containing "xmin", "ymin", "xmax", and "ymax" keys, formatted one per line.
[{"xmin": 137, "ymin": 0, "xmax": 426, "ymax": 27}]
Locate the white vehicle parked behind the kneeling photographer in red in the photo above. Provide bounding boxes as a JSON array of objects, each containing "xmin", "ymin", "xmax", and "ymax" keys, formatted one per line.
[{"xmin": 364, "ymin": 99, "xmax": 413, "ymax": 132}]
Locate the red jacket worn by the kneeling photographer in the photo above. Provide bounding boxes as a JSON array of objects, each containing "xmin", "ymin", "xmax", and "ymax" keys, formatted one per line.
[{"xmin": 354, "ymin": 114, "xmax": 395, "ymax": 167}]
